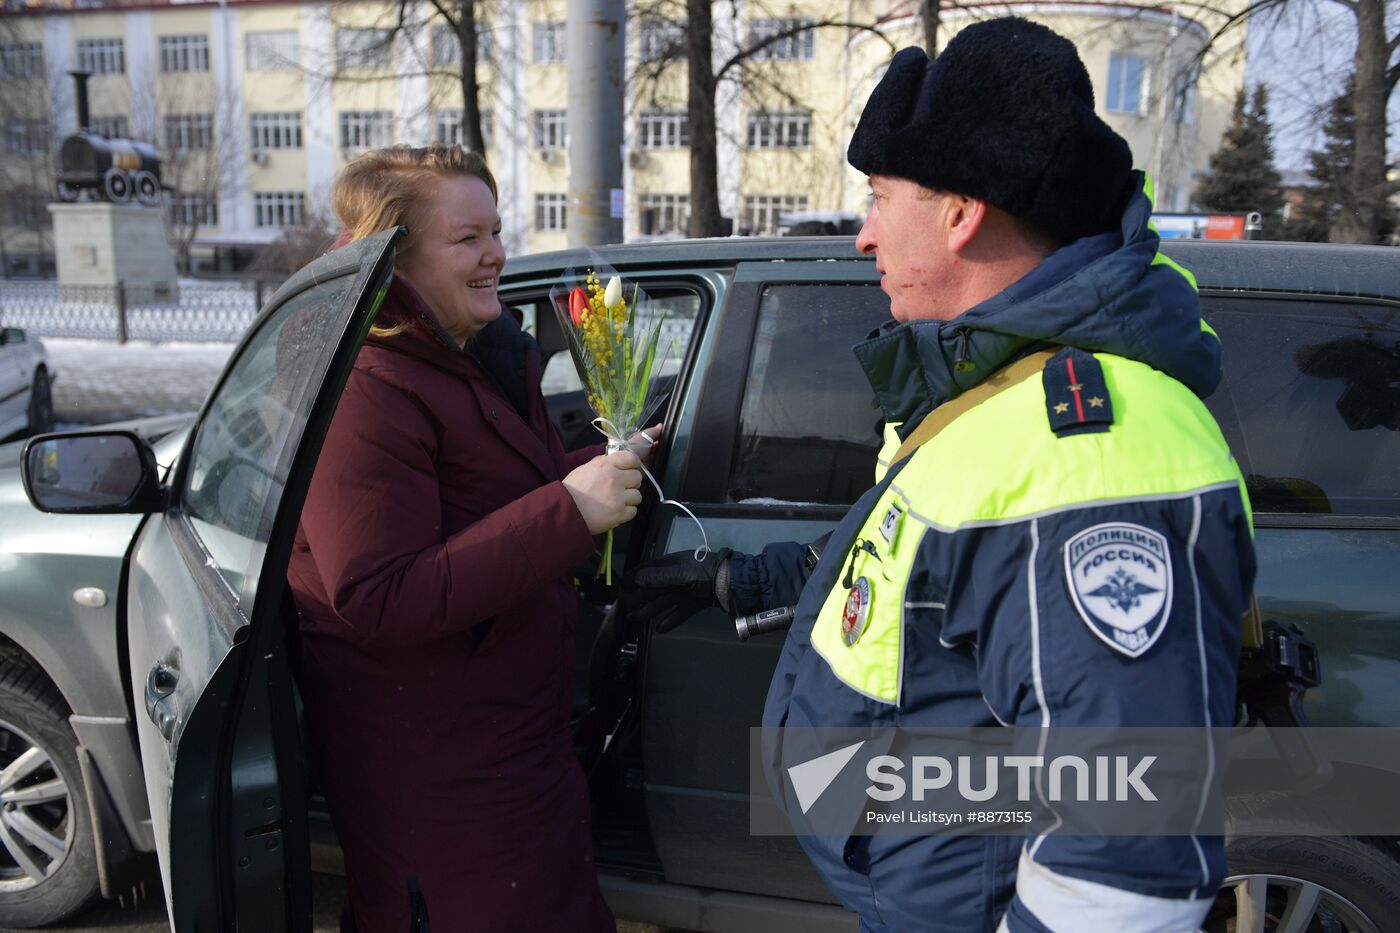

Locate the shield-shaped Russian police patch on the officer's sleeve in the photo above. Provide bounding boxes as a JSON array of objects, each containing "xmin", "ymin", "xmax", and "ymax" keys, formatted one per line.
[{"xmin": 1064, "ymin": 521, "xmax": 1172, "ymax": 657}]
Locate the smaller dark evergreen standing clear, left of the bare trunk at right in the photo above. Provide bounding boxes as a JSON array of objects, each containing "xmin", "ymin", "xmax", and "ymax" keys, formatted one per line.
[{"xmin": 1196, "ymin": 84, "xmax": 1284, "ymax": 237}]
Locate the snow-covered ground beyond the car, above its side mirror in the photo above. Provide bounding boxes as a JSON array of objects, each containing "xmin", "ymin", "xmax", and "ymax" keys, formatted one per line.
[{"xmin": 43, "ymin": 338, "xmax": 235, "ymax": 424}]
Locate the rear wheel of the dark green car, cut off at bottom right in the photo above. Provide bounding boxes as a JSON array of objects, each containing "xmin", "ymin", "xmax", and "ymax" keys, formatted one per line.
[{"xmin": 1201, "ymin": 836, "xmax": 1400, "ymax": 933}]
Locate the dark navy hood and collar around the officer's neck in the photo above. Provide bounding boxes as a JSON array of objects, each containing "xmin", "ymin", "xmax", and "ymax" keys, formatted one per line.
[{"xmin": 854, "ymin": 172, "xmax": 1221, "ymax": 436}]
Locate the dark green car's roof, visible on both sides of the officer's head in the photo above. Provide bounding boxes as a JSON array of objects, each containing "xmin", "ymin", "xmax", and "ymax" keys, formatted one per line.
[{"xmin": 501, "ymin": 237, "xmax": 1400, "ymax": 300}]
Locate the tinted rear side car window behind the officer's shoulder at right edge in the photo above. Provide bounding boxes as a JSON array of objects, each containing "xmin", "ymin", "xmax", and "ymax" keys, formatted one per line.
[{"xmin": 1210, "ymin": 300, "xmax": 1400, "ymax": 517}]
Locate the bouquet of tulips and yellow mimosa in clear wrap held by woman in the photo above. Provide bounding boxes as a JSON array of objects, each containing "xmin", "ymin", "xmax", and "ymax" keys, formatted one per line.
[{"xmin": 550, "ymin": 263, "xmax": 691, "ymax": 584}]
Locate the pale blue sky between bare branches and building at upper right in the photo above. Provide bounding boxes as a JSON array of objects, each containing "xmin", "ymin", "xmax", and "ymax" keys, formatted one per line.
[{"xmin": 1246, "ymin": 0, "xmax": 1400, "ymax": 171}]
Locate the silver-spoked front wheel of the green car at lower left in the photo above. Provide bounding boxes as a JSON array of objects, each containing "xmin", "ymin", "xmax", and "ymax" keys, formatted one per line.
[{"xmin": 0, "ymin": 658, "xmax": 98, "ymax": 927}]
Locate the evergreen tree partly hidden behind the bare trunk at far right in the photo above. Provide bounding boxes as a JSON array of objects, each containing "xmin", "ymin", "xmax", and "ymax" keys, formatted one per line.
[{"xmin": 1284, "ymin": 77, "xmax": 1397, "ymax": 242}]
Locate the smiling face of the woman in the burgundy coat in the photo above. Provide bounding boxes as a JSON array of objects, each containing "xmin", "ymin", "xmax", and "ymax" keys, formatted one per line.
[{"xmin": 395, "ymin": 175, "xmax": 505, "ymax": 343}]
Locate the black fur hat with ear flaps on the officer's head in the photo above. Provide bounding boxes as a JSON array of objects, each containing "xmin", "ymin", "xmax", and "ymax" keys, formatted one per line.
[{"xmin": 846, "ymin": 17, "xmax": 1133, "ymax": 242}]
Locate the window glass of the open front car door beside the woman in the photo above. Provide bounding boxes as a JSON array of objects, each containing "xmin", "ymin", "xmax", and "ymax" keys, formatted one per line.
[{"xmin": 181, "ymin": 276, "xmax": 354, "ymax": 612}]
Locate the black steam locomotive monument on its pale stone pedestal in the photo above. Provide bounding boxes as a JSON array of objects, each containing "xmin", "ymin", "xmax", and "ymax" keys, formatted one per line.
[{"xmin": 49, "ymin": 71, "xmax": 178, "ymax": 304}]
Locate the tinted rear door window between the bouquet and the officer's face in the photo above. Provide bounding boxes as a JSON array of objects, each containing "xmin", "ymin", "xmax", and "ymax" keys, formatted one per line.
[{"xmin": 728, "ymin": 283, "xmax": 889, "ymax": 506}]
